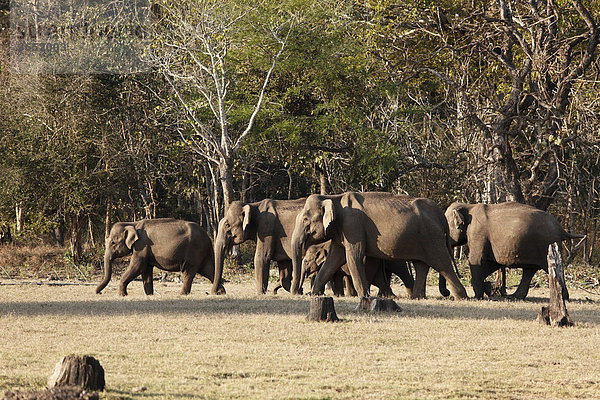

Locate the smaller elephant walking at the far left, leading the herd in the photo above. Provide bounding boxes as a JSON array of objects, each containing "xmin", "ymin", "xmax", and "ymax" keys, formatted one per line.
[{"xmin": 96, "ymin": 218, "xmax": 225, "ymax": 296}]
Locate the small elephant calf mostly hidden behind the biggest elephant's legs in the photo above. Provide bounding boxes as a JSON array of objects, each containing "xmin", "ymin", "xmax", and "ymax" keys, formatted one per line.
[{"xmin": 300, "ymin": 241, "xmax": 415, "ymax": 297}]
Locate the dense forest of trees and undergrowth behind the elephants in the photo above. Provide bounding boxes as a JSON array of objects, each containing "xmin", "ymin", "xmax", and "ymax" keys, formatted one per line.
[{"xmin": 0, "ymin": 0, "xmax": 600, "ymax": 272}]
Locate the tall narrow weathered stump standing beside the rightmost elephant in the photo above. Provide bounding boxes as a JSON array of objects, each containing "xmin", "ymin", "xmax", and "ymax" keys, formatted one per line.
[{"xmin": 537, "ymin": 243, "xmax": 573, "ymax": 326}]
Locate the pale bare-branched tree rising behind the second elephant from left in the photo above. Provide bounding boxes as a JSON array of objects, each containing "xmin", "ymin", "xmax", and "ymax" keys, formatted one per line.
[{"xmin": 154, "ymin": 0, "xmax": 293, "ymax": 225}]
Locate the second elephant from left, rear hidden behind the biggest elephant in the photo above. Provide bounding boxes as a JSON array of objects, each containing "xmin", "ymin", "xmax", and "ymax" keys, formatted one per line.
[{"xmin": 215, "ymin": 199, "xmax": 305, "ymax": 294}]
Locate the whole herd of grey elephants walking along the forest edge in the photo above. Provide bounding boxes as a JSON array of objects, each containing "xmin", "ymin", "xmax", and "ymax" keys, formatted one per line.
[{"xmin": 96, "ymin": 192, "xmax": 584, "ymax": 299}]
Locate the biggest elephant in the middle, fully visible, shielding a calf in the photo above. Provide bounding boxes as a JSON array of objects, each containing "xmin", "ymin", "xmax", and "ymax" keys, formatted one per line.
[{"xmin": 292, "ymin": 192, "xmax": 467, "ymax": 299}]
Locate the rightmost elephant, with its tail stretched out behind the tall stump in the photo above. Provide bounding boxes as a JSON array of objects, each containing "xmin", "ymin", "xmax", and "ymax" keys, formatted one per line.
[{"xmin": 445, "ymin": 202, "xmax": 585, "ymax": 299}]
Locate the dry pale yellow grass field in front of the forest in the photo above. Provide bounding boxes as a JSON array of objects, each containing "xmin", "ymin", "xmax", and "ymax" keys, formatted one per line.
[{"xmin": 0, "ymin": 278, "xmax": 600, "ymax": 399}]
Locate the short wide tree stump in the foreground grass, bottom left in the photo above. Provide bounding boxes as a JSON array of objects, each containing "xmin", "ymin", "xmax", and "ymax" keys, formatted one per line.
[{"xmin": 48, "ymin": 355, "xmax": 105, "ymax": 390}]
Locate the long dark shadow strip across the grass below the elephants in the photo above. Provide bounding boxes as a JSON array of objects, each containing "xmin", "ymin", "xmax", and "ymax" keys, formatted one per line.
[{"xmin": 0, "ymin": 296, "xmax": 600, "ymax": 324}]
